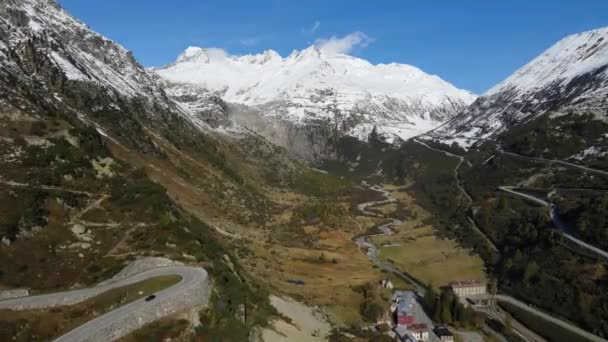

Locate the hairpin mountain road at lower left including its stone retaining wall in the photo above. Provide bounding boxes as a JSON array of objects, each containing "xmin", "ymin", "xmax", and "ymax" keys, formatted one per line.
[{"xmin": 0, "ymin": 266, "xmax": 211, "ymax": 342}]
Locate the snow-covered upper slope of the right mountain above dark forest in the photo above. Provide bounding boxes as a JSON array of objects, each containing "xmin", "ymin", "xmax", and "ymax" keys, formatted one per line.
[{"xmin": 430, "ymin": 27, "xmax": 608, "ymax": 146}]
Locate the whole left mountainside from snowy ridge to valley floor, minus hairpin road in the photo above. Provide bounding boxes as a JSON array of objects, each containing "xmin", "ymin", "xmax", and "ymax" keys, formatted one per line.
[{"xmin": 0, "ymin": 0, "xmax": 408, "ymax": 341}]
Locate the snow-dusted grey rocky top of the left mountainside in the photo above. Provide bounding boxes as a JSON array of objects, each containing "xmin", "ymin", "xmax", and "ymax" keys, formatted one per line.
[{"xmin": 0, "ymin": 0, "xmax": 164, "ymax": 104}]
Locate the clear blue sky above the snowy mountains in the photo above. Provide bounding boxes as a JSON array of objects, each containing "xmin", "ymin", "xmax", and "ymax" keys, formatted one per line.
[{"xmin": 59, "ymin": 0, "xmax": 608, "ymax": 93}]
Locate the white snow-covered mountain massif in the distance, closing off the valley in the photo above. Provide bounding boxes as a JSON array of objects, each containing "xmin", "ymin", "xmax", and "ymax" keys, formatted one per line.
[{"xmin": 154, "ymin": 46, "xmax": 476, "ymax": 139}]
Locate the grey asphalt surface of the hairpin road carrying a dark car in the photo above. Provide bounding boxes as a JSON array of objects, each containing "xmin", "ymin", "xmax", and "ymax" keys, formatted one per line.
[{"xmin": 0, "ymin": 266, "xmax": 211, "ymax": 342}]
